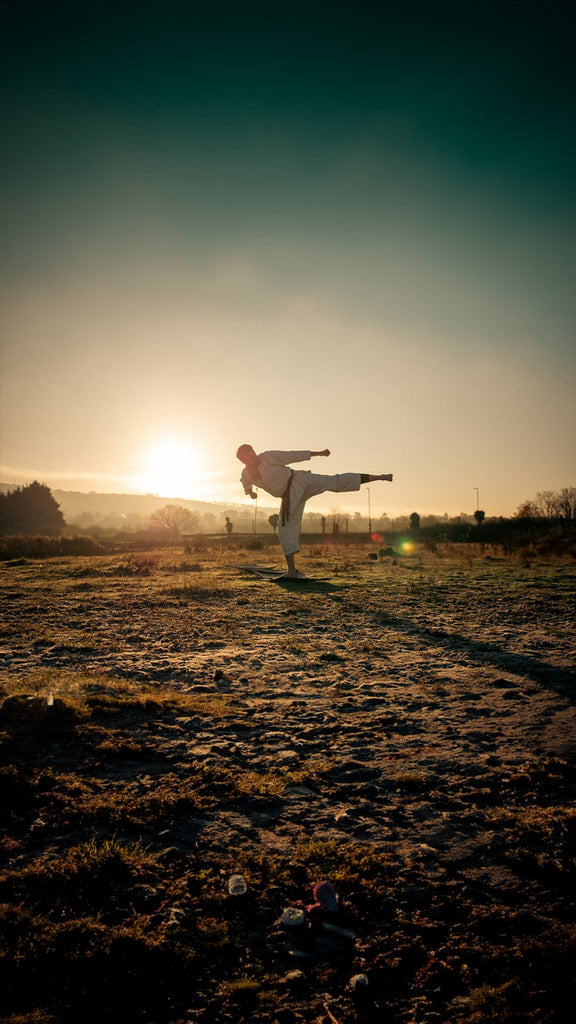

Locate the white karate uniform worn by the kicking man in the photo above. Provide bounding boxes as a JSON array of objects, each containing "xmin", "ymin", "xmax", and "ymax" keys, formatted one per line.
[{"xmin": 240, "ymin": 452, "xmax": 361, "ymax": 555}]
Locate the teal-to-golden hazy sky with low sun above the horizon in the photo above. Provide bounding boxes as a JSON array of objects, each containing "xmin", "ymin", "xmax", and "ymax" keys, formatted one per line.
[{"xmin": 0, "ymin": 0, "xmax": 576, "ymax": 516}]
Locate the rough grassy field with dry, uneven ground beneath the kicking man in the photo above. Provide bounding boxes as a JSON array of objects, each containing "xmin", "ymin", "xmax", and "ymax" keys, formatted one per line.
[{"xmin": 0, "ymin": 544, "xmax": 576, "ymax": 1024}]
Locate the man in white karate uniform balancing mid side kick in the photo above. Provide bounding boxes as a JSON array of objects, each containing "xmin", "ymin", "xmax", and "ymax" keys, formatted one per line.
[{"xmin": 236, "ymin": 444, "xmax": 393, "ymax": 580}]
